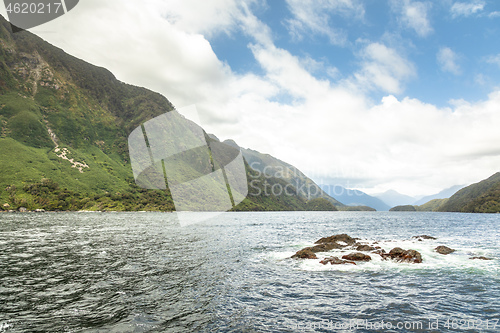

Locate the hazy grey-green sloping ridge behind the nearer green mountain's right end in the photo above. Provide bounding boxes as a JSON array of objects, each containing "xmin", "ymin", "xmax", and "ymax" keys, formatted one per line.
[{"xmin": 239, "ymin": 147, "xmax": 344, "ymax": 207}]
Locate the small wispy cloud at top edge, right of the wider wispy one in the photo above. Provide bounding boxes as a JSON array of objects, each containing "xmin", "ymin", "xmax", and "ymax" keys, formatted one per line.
[{"xmin": 391, "ymin": 0, "xmax": 433, "ymax": 37}]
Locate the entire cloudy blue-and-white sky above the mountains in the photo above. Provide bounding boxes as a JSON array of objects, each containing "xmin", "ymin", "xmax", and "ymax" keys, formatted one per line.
[{"xmin": 2, "ymin": 0, "xmax": 500, "ymax": 196}]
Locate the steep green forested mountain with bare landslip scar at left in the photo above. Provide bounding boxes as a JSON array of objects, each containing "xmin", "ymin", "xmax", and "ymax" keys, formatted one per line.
[{"xmin": 0, "ymin": 16, "xmax": 335, "ymax": 211}]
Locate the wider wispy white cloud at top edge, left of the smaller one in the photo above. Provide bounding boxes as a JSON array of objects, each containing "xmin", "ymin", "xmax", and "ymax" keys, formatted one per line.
[{"xmin": 287, "ymin": 0, "xmax": 365, "ymax": 45}]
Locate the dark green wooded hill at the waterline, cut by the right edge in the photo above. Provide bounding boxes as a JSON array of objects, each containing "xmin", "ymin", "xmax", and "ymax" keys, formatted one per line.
[{"xmin": 438, "ymin": 172, "xmax": 500, "ymax": 213}]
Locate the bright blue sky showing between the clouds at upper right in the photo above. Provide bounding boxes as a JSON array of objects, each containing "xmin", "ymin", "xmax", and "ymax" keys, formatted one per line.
[{"xmin": 208, "ymin": 0, "xmax": 500, "ymax": 106}]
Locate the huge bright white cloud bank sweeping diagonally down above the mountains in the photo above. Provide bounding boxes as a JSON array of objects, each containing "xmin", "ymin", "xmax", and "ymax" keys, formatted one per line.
[{"xmin": 9, "ymin": 0, "xmax": 500, "ymax": 194}]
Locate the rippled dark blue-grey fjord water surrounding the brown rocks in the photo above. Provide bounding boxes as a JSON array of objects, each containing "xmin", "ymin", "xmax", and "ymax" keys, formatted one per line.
[{"xmin": 0, "ymin": 212, "xmax": 500, "ymax": 333}]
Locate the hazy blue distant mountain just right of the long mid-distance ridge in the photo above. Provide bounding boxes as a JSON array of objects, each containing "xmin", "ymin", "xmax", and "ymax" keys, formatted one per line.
[{"xmin": 320, "ymin": 185, "xmax": 391, "ymax": 211}]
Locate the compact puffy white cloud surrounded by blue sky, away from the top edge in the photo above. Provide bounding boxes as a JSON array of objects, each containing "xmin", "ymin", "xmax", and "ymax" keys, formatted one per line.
[{"xmin": 354, "ymin": 43, "xmax": 416, "ymax": 94}]
